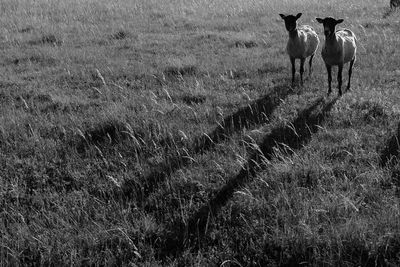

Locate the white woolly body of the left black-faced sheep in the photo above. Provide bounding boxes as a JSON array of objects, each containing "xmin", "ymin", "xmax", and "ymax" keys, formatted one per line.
[{"xmin": 286, "ymin": 25, "xmax": 319, "ymax": 58}]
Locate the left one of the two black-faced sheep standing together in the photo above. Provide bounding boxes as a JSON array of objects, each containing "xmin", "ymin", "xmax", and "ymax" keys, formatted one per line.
[{"xmin": 279, "ymin": 13, "xmax": 319, "ymax": 86}]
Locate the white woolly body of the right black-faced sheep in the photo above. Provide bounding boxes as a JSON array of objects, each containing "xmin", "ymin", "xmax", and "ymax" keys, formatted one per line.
[{"xmin": 321, "ymin": 29, "xmax": 357, "ymax": 66}]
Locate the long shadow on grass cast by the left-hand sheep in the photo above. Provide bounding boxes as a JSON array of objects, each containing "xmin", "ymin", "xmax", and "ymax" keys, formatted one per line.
[{"xmin": 122, "ymin": 85, "xmax": 293, "ymax": 205}]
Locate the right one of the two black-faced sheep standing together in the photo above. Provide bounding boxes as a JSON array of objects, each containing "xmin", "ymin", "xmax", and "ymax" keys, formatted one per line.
[{"xmin": 316, "ymin": 17, "xmax": 357, "ymax": 96}]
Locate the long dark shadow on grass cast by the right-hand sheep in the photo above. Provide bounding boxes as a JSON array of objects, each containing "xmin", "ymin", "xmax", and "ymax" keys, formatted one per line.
[{"xmin": 159, "ymin": 98, "xmax": 338, "ymax": 258}]
